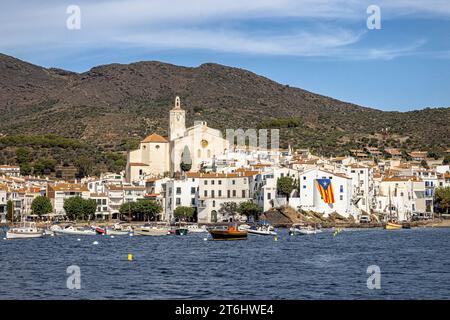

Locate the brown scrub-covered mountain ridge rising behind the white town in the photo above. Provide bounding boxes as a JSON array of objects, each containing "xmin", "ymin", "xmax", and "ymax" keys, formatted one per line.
[{"xmin": 0, "ymin": 54, "xmax": 450, "ymax": 175}]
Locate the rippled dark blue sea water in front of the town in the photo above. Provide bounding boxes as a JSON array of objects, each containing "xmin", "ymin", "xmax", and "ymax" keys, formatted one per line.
[{"xmin": 0, "ymin": 229, "xmax": 450, "ymax": 299}]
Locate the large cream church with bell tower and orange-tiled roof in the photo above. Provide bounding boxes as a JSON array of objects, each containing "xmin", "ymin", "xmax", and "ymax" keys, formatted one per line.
[{"xmin": 126, "ymin": 97, "xmax": 229, "ymax": 182}]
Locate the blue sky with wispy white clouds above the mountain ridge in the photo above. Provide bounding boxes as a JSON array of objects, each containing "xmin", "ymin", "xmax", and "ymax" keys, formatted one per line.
[{"xmin": 0, "ymin": 0, "xmax": 450, "ymax": 111}]
